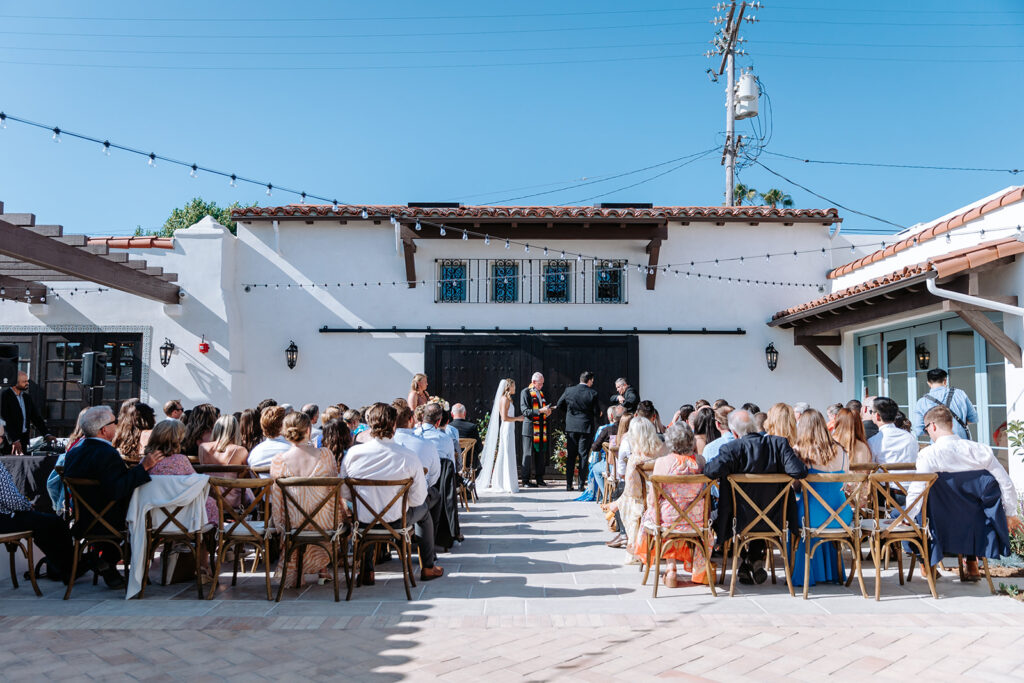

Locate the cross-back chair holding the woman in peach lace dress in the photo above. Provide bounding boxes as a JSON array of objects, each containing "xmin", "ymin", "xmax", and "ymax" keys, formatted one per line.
[{"xmin": 274, "ymin": 477, "xmax": 352, "ymax": 602}]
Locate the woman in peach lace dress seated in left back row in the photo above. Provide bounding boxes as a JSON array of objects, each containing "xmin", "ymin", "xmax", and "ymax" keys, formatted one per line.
[{"xmin": 270, "ymin": 407, "xmax": 341, "ymax": 587}]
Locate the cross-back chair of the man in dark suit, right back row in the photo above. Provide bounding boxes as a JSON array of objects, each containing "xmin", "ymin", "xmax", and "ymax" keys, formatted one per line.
[{"xmin": 722, "ymin": 474, "xmax": 795, "ymax": 597}]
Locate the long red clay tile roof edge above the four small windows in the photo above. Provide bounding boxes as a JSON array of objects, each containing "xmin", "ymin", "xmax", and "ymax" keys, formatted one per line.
[{"xmin": 231, "ymin": 204, "xmax": 843, "ymax": 224}]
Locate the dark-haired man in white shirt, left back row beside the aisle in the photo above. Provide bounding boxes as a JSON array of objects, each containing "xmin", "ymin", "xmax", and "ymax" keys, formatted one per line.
[{"xmin": 338, "ymin": 403, "xmax": 442, "ymax": 585}]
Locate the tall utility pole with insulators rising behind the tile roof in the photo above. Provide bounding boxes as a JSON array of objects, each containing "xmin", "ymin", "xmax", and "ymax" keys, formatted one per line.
[{"xmin": 705, "ymin": 0, "xmax": 764, "ymax": 206}]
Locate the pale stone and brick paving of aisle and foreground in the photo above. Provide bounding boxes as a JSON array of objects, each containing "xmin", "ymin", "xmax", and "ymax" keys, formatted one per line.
[{"xmin": 0, "ymin": 487, "xmax": 1024, "ymax": 681}]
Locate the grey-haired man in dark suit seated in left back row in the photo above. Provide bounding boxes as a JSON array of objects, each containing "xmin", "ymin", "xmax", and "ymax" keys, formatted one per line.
[{"xmin": 65, "ymin": 405, "xmax": 164, "ymax": 588}]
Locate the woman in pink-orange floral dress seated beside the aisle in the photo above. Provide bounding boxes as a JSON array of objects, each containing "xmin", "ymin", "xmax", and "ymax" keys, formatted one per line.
[{"xmin": 633, "ymin": 422, "xmax": 714, "ymax": 588}]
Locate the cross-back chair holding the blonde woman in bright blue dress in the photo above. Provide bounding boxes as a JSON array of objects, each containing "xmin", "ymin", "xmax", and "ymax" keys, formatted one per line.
[{"xmin": 793, "ymin": 473, "xmax": 868, "ymax": 600}]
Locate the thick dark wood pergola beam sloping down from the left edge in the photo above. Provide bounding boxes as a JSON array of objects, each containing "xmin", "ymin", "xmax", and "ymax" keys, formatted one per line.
[{"xmin": 0, "ymin": 220, "xmax": 181, "ymax": 304}]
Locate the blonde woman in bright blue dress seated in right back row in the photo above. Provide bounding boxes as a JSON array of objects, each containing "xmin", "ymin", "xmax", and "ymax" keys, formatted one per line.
[{"xmin": 793, "ymin": 410, "xmax": 853, "ymax": 586}]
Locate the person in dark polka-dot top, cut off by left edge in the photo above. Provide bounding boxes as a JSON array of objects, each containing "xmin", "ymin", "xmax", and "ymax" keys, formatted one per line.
[{"xmin": 0, "ymin": 420, "xmax": 73, "ymax": 584}]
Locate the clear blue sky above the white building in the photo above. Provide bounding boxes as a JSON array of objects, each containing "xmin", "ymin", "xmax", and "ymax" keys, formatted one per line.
[{"xmin": 0, "ymin": 0, "xmax": 1024, "ymax": 234}]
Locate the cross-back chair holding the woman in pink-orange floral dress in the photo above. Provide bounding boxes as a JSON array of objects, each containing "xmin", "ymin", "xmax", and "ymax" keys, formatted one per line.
[{"xmin": 640, "ymin": 474, "xmax": 718, "ymax": 598}]
